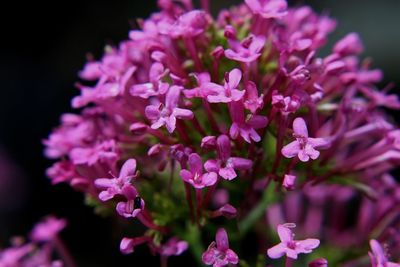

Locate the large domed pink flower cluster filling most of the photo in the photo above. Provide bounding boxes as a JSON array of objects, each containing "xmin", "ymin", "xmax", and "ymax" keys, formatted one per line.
[{"xmin": 44, "ymin": 0, "xmax": 400, "ymax": 267}]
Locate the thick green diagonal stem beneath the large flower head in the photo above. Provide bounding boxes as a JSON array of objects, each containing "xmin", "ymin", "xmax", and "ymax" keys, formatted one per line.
[{"xmin": 239, "ymin": 184, "xmax": 275, "ymax": 236}]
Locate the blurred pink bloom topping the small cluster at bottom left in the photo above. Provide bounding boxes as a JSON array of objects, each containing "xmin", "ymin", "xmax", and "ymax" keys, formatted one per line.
[{"xmin": 30, "ymin": 216, "xmax": 67, "ymax": 242}]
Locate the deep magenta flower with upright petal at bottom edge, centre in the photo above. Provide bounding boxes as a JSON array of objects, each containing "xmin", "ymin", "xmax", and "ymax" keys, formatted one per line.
[{"xmin": 202, "ymin": 228, "xmax": 239, "ymax": 267}]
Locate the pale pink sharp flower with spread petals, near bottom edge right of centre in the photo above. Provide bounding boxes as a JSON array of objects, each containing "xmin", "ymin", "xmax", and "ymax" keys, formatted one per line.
[{"xmin": 267, "ymin": 223, "xmax": 319, "ymax": 259}]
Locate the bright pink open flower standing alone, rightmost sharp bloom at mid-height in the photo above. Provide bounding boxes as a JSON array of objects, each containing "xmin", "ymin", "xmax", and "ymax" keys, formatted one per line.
[{"xmin": 282, "ymin": 118, "xmax": 330, "ymax": 162}]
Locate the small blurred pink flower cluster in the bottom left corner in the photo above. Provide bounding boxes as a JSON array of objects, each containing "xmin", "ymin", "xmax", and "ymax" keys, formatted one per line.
[{"xmin": 0, "ymin": 216, "xmax": 67, "ymax": 267}]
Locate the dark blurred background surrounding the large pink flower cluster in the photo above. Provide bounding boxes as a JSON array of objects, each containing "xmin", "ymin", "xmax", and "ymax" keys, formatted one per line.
[{"xmin": 0, "ymin": 0, "xmax": 400, "ymax": 266}]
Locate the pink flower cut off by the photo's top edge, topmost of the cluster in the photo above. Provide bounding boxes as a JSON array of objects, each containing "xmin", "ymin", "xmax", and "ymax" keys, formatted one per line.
[{"xmin": 245, "ymin": 0, "xmax": 287, "ymax": 19}]
